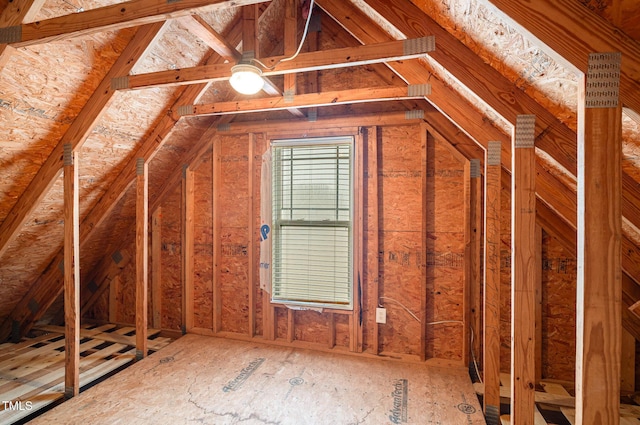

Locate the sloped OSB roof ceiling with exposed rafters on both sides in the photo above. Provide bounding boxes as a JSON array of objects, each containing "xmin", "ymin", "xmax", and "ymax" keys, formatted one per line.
[{"xmin": 0, "ymin": 0, "xmax": 640, "ymax": 339}]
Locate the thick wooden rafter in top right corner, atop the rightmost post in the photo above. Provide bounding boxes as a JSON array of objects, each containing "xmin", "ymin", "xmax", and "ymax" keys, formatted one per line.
[{"xmin": 490, "ymin": 0, "xmax": 640, "ymax": 112}]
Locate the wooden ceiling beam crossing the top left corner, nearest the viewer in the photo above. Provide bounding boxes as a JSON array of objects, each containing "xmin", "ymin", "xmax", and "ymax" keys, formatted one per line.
[{"xmin": 0, "ymin": 0, "xmax": 269, "ymax": 47}]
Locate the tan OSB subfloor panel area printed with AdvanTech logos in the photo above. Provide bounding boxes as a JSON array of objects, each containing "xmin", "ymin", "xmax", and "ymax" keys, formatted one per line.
[{"xmin": 32, "ymin": 335, "xmax": 485, "ymax": 425}]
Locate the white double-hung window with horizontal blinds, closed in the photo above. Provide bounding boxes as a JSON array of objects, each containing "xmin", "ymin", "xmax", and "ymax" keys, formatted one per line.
[{"xmin": 271, "ymin": 137, "xmax": 353, "ymax": 309}]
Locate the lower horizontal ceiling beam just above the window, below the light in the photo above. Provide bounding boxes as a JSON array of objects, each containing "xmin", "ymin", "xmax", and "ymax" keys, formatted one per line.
[{"xmin": 179, "ymin": 86, "xmax": 429, "ymax": 116}]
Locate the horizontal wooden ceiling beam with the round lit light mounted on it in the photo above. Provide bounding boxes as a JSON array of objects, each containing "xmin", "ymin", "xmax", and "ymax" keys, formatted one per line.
[{"xmin": 112, "ymin": 37, "xmax": 434, "ymax": 89}]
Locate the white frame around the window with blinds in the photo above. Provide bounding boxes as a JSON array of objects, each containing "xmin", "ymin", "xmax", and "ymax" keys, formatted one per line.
[{"xmin": 270, "ymin": 135, "xmax": 357, "ymax": 311}]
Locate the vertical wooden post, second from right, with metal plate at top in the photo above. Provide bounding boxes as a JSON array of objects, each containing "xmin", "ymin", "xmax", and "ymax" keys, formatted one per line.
[{"xmin": 511, "ymin": 115, "xmax": 536, "ymax": 425}]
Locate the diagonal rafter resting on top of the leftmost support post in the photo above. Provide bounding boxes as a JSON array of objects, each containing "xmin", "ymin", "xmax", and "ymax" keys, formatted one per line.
[{"xmin": 0, "ymin": 23, "xmax": 163, "ymax": 264}]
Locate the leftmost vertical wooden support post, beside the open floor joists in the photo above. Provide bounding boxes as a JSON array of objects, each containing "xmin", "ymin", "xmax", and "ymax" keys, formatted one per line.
[{"xmin": 64, "ymin": 144, "xmax": 80, "ymax": 398}]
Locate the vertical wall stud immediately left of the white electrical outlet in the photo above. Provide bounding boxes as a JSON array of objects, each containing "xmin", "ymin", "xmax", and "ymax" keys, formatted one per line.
[{"xmin": 367, "ymin": 127, "xmax": 380, "ymax": 354}]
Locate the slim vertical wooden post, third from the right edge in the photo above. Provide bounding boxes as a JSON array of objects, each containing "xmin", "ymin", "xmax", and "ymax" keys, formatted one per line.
[{"xmin": 482, "ymin": 142, "xmax": 502, "ymax": 425}]
